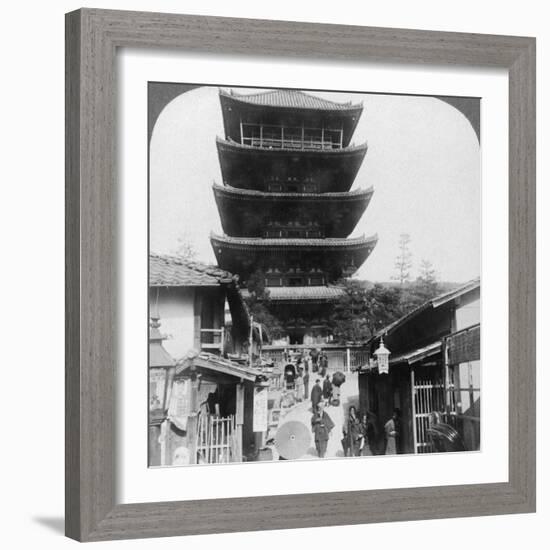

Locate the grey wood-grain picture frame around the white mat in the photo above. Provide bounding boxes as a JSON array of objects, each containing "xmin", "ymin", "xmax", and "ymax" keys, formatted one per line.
[{"xmin": 66, "ymin": 9, "xmax": 536, "ymax": 541}]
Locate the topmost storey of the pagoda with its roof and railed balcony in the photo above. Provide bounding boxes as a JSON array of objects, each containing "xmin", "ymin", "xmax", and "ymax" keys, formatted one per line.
[{"xmin": 220, "ymin": 90, "xmax": 363, "ymax": 150}]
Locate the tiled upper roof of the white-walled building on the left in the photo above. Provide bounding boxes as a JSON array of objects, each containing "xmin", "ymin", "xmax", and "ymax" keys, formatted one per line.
[{"xmin": 149, "ymin": 253, "xmax": 236, "ymax": 286}]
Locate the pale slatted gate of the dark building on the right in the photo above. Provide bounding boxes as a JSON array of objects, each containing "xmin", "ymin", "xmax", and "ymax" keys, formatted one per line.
[{"xmin": 411, "ymin": 369, "xmax": 445, "ymax": 453}]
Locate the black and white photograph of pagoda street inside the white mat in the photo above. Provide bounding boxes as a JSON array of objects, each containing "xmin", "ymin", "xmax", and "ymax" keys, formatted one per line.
[{"xmin": 149, "ymin": 82, "xmax": 482, "ymax": 467}]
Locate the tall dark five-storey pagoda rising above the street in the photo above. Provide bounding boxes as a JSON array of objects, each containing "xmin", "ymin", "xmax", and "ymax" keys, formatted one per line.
[{"xmin": 210, "ymin": 90, "xmax": 377, "ymax": 345}]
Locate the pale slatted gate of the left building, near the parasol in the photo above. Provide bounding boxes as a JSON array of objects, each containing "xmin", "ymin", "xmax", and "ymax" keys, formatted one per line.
[{"xmin": 197, "ymin": 414, "xmax": 240, "ymax": 464}]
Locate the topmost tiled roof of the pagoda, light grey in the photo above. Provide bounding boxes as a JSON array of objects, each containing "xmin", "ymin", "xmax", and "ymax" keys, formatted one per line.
[{"xmin": 220, "ymin": 90, "xmax": 363, "ymax": 111}]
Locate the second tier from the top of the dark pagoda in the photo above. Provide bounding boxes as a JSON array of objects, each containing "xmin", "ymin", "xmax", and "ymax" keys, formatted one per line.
[{"xmin": 216, "ymin": 138, "xmax": 367, "ymax": 193}]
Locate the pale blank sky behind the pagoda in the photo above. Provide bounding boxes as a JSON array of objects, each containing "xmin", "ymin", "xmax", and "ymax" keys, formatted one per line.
[{"xmin": 149, "ymin": 87, "xmax": 481, "ymax": 282}]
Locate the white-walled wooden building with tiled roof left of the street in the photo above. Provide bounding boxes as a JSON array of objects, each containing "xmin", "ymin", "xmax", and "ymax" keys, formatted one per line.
[{"xmin": 149, "ymin": 254, "xmax": 267, "ymax": 466}]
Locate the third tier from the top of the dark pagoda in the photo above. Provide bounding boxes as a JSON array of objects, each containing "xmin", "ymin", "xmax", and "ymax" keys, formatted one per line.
[{"xmin": 213, "ymin": 184, "xmax": 374, "ymax": 238}]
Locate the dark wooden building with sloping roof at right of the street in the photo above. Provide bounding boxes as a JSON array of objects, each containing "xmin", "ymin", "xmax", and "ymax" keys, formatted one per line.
[{"xmin": 358, "ymin": 279, "xmax": 480, "ymax": 453}]
